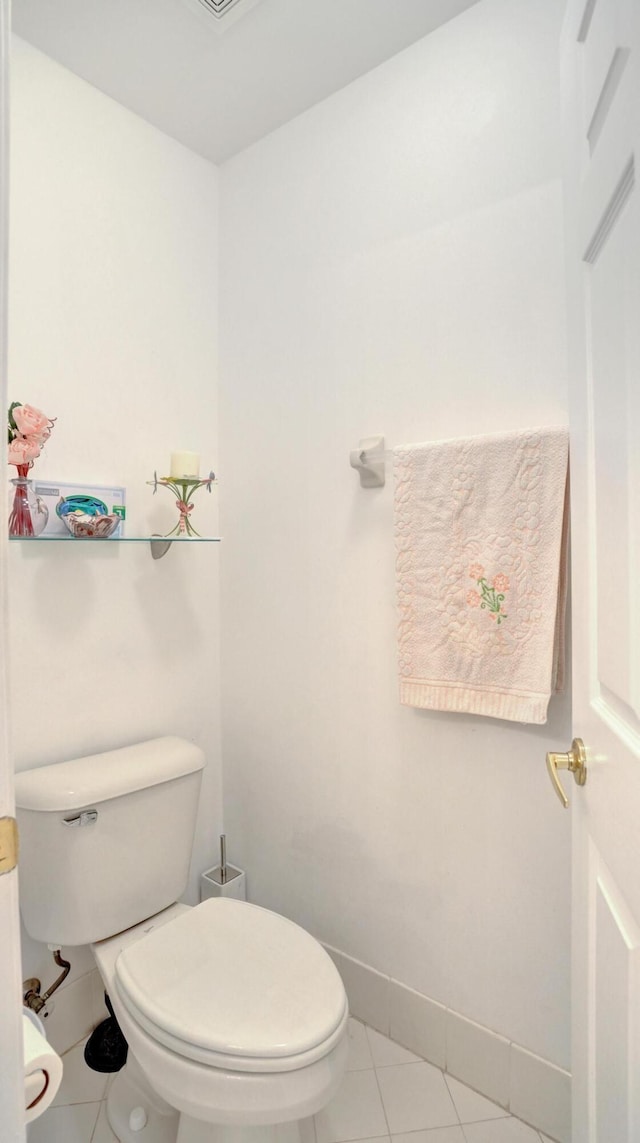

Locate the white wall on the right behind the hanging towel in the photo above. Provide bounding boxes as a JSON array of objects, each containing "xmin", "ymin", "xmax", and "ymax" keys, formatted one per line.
[{"xmin": 221, "ymin": 0, "xmax": 570, "ymax": 1066}]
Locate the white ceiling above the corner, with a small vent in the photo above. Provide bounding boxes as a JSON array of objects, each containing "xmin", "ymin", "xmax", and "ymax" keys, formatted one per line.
[{"xmin": 13, "ymin": 0, "xmax": 477, "ymax": 162}]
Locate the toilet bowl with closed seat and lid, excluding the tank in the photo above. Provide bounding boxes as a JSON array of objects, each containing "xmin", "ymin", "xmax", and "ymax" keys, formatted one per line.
[{"xmin": 93, "ymin": 898, "xmax": 349, "ymax": 1138}]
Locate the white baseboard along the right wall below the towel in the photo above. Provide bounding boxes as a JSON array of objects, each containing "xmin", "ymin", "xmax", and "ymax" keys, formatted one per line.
[{"xmin": 325, "ymin": 945, "xmax": 571, "ymax": 1143}]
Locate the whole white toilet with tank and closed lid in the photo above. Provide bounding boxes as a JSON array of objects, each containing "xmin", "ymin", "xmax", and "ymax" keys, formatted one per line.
[{"xmin": 16, "ymin": 737, "xmax": 347, "ymax": 1143}]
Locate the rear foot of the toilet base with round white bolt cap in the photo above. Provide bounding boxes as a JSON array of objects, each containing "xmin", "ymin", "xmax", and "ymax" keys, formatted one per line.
[{"xmin": 106, "ymin": 1053, "xmax": 179, "ymax": 1143}]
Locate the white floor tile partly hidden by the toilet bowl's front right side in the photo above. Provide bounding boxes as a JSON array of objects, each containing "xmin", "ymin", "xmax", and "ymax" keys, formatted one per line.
[{"xmin": 315, "ymin": 1070, "xmax": 389, "ymax": 1143}]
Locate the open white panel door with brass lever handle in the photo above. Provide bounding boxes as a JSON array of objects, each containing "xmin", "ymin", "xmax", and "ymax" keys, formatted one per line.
[{"xmin": 562, "ymin": 0, "xmax": 640, "ymax": 1143}]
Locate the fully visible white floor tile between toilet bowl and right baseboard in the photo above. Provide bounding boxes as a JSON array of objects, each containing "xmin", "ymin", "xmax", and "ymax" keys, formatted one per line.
[{"xmin": 376, "ymin": 1063, "xmax": 459, "ymax": 1135}]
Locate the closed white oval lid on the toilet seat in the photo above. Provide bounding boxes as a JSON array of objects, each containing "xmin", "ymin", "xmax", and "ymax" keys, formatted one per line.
[{"xmin": 115, "ymin": 898, "xmax": 346, "ymax": 1064}]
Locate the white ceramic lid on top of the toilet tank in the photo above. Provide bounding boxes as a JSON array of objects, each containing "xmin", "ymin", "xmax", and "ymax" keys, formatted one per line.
[{"xmin": 16, "ymin": 737, "xmax": 205, "ymax": 812}]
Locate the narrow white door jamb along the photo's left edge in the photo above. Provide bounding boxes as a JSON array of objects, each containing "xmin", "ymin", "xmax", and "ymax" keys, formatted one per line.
[{"xmin": 0, "ymin": 0, "xmax": 24, "ymax": 1143}]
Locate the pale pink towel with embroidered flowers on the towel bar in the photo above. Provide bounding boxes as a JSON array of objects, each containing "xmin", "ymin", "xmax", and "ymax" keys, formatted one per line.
[{"xmin": 393, "ymin": 429, "xmax": 568, "ymax": 722}]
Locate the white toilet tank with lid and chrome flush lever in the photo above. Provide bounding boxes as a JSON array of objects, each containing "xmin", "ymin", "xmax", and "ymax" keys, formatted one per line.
[{"xmin": 16, "ymin": 737, "xmax": 205, "ymax": 946}]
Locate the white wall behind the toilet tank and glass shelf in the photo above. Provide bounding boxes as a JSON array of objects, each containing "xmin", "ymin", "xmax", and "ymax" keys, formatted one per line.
[{"xmin": 9, "ymin": 39, "xmax": 221, "ymax": 1046}]
